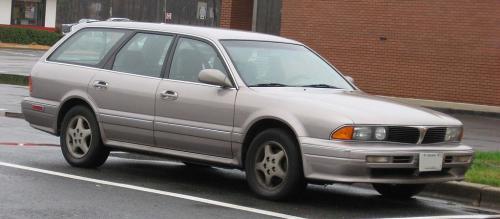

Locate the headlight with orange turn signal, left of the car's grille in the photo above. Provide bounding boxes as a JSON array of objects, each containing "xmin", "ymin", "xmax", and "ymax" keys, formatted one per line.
[{"xmin": 331, "ymin": 126, "xmax": 387, "ymax": 141}]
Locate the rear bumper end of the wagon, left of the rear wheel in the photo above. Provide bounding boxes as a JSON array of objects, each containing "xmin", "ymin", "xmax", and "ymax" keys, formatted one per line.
[{"xmin": 21, "ymin": 97, "xmax": 58, "ymax": 135}]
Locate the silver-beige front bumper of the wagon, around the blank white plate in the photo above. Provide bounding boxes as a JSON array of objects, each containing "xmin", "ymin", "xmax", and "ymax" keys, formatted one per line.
[{"xmin": 299, "ymin": 137, "xmax": 474, "ymax": 184}]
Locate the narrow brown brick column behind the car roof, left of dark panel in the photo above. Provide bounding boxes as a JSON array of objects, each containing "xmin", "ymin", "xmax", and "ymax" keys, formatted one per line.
[{"xmin": 220, "ymin": 0, "xmax": 253, "ymax": 30}]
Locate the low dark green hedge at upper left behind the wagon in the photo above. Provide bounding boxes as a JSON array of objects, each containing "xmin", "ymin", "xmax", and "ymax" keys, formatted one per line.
[{"xmin": 0, "ymin": 27, "xmax": 61, "ymax": 46}]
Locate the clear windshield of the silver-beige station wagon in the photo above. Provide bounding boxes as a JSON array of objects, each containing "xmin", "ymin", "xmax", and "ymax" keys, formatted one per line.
[{"xmin": 222, "ymin": 40, "xmax": 353, "ymax": 90}]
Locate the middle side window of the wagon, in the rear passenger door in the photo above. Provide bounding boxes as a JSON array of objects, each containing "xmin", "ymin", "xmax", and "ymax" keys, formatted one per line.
[{"xmin": 113, "ymin": 33, "xmax": 173, "ymax": 77}]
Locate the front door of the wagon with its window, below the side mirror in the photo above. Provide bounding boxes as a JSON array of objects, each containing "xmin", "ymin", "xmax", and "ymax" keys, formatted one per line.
[{"xmin": 154, "ymin": 37, "xmax": 237, "ymax": 157}]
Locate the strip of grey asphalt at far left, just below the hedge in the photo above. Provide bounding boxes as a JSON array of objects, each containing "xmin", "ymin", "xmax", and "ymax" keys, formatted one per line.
[{"xmin": 0, "ymin": 49, "xmax": 45, "ymax": 75}]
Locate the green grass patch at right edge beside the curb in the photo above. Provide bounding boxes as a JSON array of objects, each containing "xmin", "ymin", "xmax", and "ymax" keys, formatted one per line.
[{"xmin": 465, "ymin": 152, "xmax": 500, "ymax": 187}]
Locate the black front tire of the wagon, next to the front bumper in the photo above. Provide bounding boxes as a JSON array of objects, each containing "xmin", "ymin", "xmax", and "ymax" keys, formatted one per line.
[{"xmin": 245, "ymin": 128, "xmax": 307, "ymax": 200}]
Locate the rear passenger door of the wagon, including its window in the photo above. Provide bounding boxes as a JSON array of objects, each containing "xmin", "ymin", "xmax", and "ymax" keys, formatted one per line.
[{"xmin": 88, "ymin": 32, "xmax": 174, "ymax": 146}]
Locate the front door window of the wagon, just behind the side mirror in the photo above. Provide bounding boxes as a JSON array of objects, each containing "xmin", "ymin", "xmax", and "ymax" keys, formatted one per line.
[{"xmin": 169, "ymin": 38, "xmax": 227, "ymax": 82}]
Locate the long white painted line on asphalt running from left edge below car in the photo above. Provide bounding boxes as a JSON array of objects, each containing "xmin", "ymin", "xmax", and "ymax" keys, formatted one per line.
[{"xmin": 0, "ymin": 161, "xmax": 300, "ymax": 219}]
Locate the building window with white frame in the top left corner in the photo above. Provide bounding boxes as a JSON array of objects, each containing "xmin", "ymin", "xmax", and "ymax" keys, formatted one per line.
[{"xmin": 11, "ymin": 0, "xmax": 46, "ymax": 26}]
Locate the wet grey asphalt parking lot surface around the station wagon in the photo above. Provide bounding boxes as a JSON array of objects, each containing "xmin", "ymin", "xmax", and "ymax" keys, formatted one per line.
[{"xmin": 0, "ymin": 47, "xmax": 500, "ymax": 218}]
